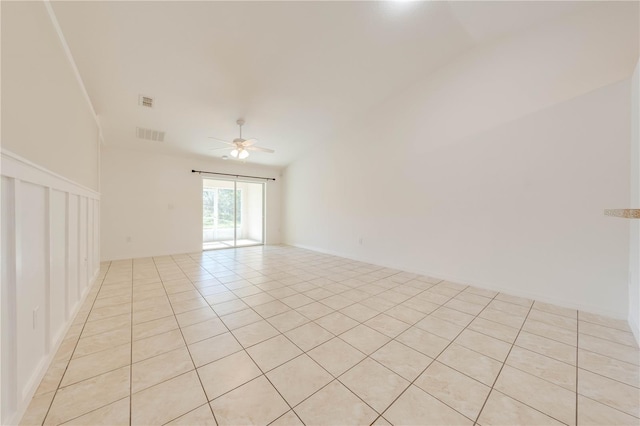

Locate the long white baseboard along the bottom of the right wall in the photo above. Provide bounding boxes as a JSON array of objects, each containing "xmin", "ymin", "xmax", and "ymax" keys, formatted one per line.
[{"xmin": 286, "ymin": 243, "xmax": 624, "ymax": 320}]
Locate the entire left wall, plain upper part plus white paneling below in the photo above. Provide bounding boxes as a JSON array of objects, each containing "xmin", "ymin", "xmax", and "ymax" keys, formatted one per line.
[{"xmin": 0, "ymin": 2, "xmax": 100, "ymax": 425}]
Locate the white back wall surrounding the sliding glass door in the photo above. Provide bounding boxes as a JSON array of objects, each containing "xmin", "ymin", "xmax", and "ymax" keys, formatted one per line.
[{"xmin": 101, "ymin": 146, "xmax": 281, "ymax": 260}]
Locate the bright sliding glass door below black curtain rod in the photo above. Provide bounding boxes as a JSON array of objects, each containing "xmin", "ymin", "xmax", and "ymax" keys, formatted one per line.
[{"xmin": 202, "ymin": 179, "xmax": 264, "ymax": 250}]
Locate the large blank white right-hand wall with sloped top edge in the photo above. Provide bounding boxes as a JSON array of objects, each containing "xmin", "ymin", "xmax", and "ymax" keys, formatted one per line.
[{"xmin": 284, "ymin": 5, "xmax": 637, "ymax": 318}]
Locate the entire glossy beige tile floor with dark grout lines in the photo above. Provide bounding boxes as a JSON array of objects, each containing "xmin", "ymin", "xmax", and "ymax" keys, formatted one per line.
[{"xmin": 22, "ymin": 246, "xmax": 640, "ymax": 426}]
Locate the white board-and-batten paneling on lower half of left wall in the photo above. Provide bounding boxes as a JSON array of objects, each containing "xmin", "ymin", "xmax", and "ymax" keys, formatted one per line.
[{"xmin": 0, "ymin": 151, "xmax": 100, "ymax": 425}]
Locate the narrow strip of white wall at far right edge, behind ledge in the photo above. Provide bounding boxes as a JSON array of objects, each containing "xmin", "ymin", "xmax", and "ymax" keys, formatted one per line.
[{"xmin": 629, "ymin": 61, "xmax": 640, "ymax": 344}]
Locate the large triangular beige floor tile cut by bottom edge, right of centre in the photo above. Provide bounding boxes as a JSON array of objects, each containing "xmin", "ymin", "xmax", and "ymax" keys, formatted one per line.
[{"xmin": 383, "ymin": 385, "xmax": 473, "ymax": 425}]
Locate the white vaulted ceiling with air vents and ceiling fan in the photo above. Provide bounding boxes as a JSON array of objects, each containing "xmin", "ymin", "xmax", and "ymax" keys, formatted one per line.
[{"xmin": 53, "ymin": 1, "xmax": 589, "ymax": 166}]
